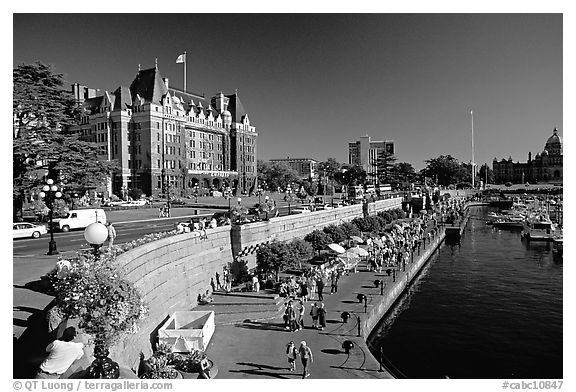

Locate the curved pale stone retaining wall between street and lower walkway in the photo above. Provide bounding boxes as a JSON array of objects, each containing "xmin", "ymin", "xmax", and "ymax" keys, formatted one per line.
[{"xmin": 72, "ymin": 198, "xmax": 402, "ymax": 369}]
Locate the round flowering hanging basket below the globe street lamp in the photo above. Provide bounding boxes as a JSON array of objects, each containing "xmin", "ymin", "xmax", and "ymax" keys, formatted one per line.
[{"xmin": 49, "ymin": 253, "xmax": 148, "ymax": 347}]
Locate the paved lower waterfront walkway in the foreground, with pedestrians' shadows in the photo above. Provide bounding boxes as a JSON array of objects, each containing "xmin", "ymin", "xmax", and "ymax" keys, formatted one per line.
[{"xmin": 207, "ymin": 268, "xmax": 393, "ymax": 379}]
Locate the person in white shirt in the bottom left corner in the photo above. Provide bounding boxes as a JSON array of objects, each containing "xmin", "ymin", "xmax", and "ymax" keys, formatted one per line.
[{"xmin": 36, "ymin": 327, "xmax": 84, "ymax": 379}]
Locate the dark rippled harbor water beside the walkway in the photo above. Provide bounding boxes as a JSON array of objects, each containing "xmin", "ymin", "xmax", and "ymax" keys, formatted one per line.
[{"xmin": 368, "ymin": 207, "xmax": 563, "ymax": 379}]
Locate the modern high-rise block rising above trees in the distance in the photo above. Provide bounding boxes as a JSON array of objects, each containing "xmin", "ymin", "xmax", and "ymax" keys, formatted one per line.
[{"xmin": 348, "ymin": 135, "xmax": 395, "ymax": 177}]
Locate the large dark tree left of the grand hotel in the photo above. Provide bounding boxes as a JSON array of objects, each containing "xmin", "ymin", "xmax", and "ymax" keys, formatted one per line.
[{"xmin": 12, "ymin": 62, "xmax": 116, "ymax": 219}]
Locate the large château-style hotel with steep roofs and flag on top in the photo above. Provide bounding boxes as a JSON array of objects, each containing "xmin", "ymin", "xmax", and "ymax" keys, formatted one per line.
[{"xmin": 72, "ymin": 66, "xmax": 258, "ymax": 197}]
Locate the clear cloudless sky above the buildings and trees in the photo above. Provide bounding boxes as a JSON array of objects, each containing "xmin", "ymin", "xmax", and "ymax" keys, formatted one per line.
[{"xmin": 13, "ymin": 12, "xmax": 564, "ymax": 169}]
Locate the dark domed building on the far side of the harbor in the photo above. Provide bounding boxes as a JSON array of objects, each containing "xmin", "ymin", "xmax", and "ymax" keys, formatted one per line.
[{"xmin": 492, "ymin": 128, "xmax": 563, "ymax": 184}]
